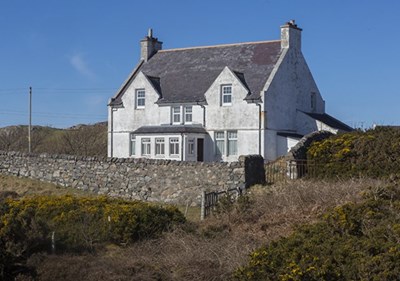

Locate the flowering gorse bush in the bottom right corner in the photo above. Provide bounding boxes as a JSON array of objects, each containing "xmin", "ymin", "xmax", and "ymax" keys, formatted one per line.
[{"xmin": 235, "ymin": 187, "xmax": 400, "ymax": 281}]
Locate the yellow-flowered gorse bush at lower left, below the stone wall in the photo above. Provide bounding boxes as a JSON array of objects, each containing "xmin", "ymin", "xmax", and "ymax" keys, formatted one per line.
[{"xmin": 0, "ymin": 195, "xmax": 185, "ymax": 279}]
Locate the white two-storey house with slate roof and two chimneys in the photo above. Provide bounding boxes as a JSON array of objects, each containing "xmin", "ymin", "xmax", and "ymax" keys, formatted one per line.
[{"xmin": 108, "ymin": 21, "xmax": 351, "ymax": 162}]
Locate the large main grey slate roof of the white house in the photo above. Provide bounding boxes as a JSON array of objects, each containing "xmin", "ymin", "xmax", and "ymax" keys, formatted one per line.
[{"xmin": 113, "ymin": 41, "xmax": 281, "ymax": 103}]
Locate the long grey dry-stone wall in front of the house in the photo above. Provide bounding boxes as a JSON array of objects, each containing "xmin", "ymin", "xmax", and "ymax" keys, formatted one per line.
[{"xmin": 0, "ymin": 151, "xmax": 265, "ymax": 205}]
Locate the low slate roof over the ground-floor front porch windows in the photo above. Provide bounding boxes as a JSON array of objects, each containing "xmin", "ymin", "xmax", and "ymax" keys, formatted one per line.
[{"xmin": 133, "ymin": 125, "xmax": 207, "ymax": 135}]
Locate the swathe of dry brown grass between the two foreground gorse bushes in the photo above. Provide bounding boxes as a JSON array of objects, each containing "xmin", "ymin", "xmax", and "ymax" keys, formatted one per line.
[{"xmin": 23, "ymin": 180, "xmax": 383, "ymax": 281}]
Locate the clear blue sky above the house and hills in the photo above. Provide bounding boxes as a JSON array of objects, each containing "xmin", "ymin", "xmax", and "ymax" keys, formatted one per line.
[{"xmin": 0, "ymin": 0, "xmax": 400, "ymax": 128}]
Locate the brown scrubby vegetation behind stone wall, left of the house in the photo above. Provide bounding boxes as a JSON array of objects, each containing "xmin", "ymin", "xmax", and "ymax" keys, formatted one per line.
[{"xmin": 0, "ymin": 122, "xmax": 107, "ymax": 157}]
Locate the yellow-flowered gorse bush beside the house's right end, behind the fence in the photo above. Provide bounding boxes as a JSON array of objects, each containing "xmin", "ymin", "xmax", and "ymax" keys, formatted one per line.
[{"xmin": 307, "ymin": 127, "xmax": 400, "ymax": 178}]
